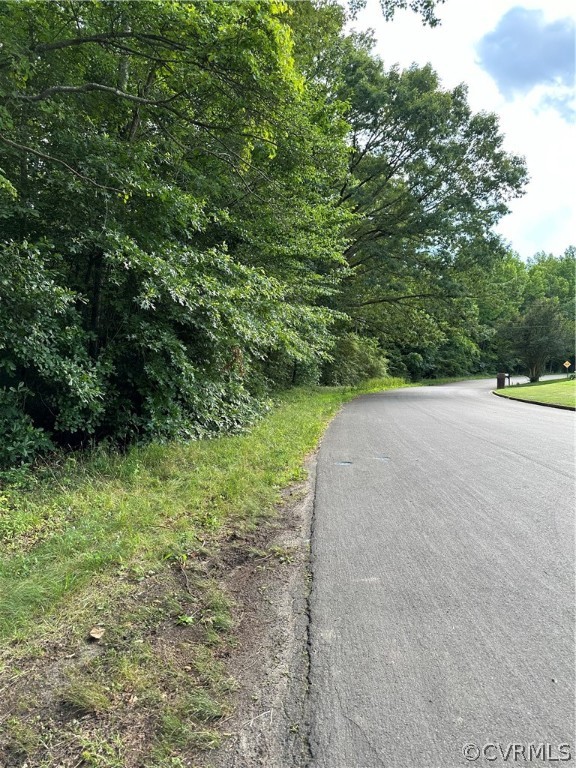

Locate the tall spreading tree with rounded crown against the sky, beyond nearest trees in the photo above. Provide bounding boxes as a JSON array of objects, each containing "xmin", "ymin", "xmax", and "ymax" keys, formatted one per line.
[{"xmin": 322, "ymin": 35, "xmax": 526, "ymax": 375}]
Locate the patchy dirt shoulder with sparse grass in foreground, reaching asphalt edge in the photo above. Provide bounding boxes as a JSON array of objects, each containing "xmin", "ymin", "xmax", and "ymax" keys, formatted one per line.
[{"xmin": 0, "ymin": 460, "xmax": 315, "ymax": 768}]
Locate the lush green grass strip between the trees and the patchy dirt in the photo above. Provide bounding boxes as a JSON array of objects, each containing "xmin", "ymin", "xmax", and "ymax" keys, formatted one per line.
[{"xmin": 0, "ymin": 379, "xmax": 403, "ymax": 640}]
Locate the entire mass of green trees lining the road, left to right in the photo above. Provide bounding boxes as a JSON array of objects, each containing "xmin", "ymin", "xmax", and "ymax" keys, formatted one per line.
[{"xmin": 0, "ymin": 0, "xmax": 574, "ymax": 466}]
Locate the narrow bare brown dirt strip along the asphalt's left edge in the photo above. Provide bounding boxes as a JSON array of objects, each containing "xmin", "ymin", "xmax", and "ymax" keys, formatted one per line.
[{"xmin": 202, "ymin": 459, "xmax": 315, "ymax": 768}]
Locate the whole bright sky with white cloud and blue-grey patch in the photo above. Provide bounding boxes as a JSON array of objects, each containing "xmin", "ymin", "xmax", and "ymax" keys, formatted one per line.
[{"xmin": 350, "ymin": 0, "xmax": 576, "ymax": 259}]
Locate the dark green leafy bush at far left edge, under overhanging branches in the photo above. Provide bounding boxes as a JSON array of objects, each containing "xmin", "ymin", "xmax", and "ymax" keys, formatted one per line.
[{"xmin": 0, "ymin": 240, "xmax": 105, "ymax": 468}]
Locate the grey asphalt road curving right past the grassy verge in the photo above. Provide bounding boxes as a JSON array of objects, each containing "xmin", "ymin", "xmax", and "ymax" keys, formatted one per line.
[{"xmin": 309, "ymin": 381, "xmax": 576, "ymax": 768}]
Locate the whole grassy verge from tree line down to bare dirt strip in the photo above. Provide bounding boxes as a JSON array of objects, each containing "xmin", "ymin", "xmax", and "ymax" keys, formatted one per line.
[{"xmin": 0, "ymin": 379, "xmax": 404, "ymax": 768}]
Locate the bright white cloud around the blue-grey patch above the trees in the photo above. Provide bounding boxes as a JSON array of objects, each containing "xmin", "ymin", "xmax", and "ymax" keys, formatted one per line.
[{"xmin": 350, "ymin": 0, "xmax": 576, "ymax": 258}]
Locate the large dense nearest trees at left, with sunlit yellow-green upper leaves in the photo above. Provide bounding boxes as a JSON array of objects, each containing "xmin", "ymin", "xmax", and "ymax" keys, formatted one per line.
[{"xmin": 0, "ymin": 0, "xmax": 350, "ymax": 466}]
